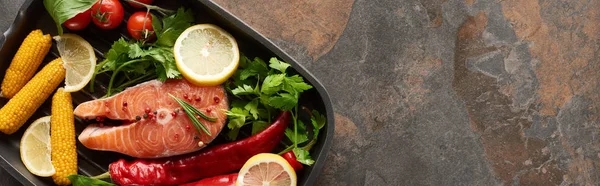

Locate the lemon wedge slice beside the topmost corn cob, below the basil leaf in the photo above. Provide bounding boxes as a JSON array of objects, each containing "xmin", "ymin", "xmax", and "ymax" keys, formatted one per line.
[{"xmin": 54, "ymin": 34, "xmax": 96, "ymax": 92}]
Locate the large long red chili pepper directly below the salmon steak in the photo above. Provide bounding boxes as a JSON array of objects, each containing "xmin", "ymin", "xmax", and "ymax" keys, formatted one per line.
[{"xmin": 109, "ymin": 112, "xmax": 291, "ymax": 185}]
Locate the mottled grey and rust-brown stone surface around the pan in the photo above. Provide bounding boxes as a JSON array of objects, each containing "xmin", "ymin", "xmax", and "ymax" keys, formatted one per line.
[{"xmin": 0, "ymin": 0, "xmax": 600, "ymax": 185}]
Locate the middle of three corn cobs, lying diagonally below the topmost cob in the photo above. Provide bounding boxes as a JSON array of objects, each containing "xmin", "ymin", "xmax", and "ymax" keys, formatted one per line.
[{"xmin": 0, "ymin": 58, "xmax": 65, "ymax": 134}]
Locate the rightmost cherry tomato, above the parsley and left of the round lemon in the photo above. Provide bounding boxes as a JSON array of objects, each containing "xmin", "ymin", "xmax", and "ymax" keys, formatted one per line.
[{"xmin": 127, "ymin": 11, "xmax": 156, "ymax": 41}]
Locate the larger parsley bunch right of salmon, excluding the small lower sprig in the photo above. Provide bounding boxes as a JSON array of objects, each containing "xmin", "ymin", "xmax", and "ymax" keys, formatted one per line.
[{"xmin": 227, "ymin": 55, "xmax": 312, "ymax": 140}]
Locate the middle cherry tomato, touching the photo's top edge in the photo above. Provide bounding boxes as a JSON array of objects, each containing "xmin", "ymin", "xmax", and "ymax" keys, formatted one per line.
[{"xmin": 90, "ymin": 0, "xmax": 123, "ymax": 30}]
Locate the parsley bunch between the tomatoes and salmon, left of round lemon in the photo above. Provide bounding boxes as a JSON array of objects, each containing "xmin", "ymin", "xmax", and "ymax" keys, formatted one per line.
[{"xmin": 90, "ymin": 8, "xmax": 194, "ymax": 96}]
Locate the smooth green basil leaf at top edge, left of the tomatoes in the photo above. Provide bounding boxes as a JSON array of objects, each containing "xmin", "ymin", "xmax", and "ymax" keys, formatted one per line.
[{"xmin": 44, "ymin": 0, "xmax": 98, "ymax": 35}]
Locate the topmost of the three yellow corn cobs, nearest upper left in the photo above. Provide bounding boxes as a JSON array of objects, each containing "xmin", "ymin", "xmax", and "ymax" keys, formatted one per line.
[{"xmin": 1, "ymin": 29, "xmax": 52, "ymax": 98}]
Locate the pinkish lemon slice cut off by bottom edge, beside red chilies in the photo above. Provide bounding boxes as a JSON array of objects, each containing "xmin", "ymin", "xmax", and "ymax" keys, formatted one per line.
[{"xmin": 236, "ymin": 153, "xmax": 297, "ymax": 186}]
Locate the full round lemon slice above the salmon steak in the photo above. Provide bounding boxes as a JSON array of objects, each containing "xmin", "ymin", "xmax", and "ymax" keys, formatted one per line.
[{"xmin": 173, "ymin": 24, "xmax": 240, "ymax": 86}]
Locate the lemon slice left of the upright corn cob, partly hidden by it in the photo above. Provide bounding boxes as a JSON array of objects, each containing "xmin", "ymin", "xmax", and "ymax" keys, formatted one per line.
[{"xmin": 20, "ymin": 116, "xmax": 56, "ymax": 177}]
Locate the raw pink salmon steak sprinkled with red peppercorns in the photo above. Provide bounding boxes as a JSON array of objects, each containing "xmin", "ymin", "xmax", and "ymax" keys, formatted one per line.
[{"xmin": 74, "ymin": 79, "xmax": 228, "ymax": 158}]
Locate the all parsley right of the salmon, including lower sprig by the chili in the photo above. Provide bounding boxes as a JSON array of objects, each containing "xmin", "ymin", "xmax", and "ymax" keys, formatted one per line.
[{"xmin": 226, "ymin": 55, "xmax": 326, "ymax": 165}]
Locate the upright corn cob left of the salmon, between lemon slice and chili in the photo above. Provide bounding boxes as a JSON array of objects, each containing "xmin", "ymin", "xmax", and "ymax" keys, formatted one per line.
[{"xmin": 50, "ymin": 88, "xmax": 77, "ymax": 185}]
